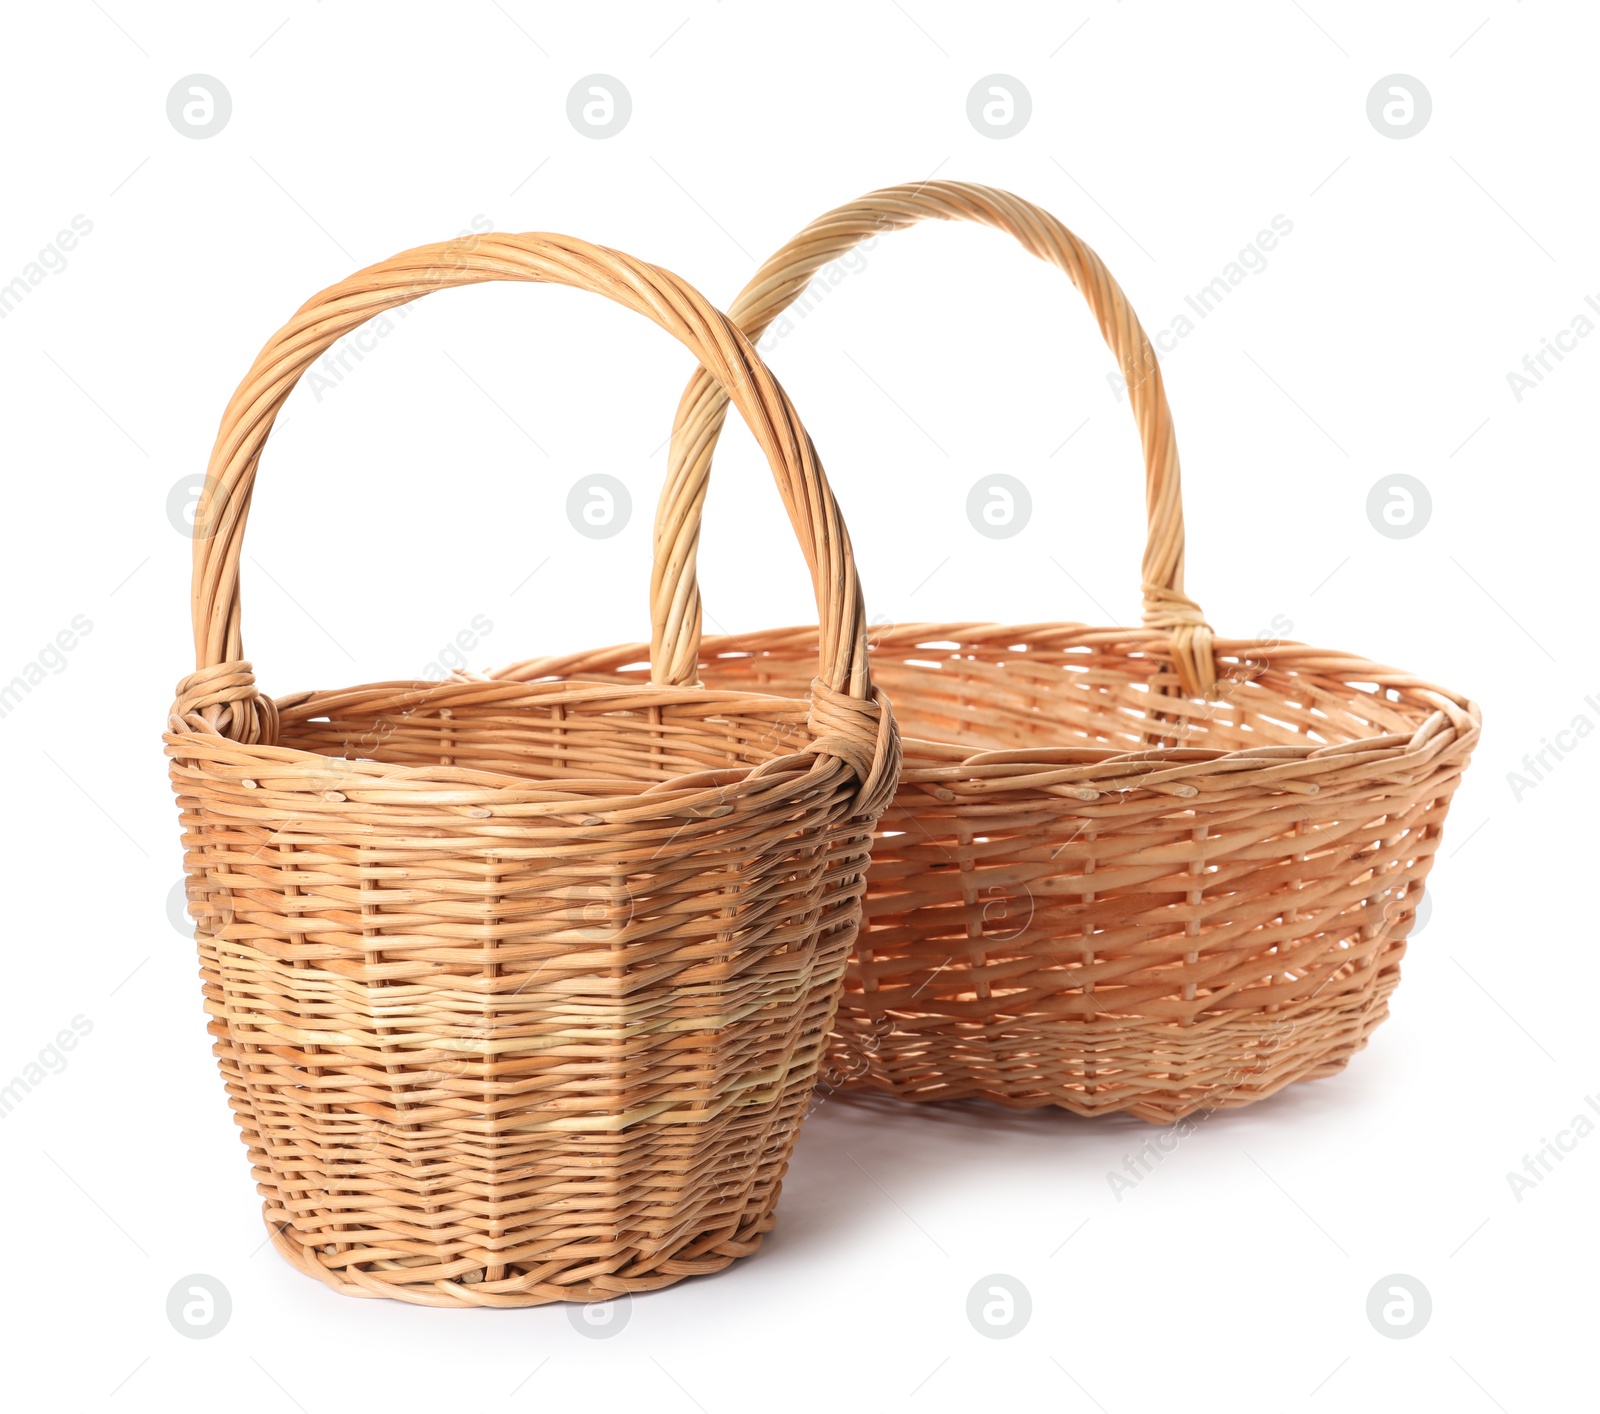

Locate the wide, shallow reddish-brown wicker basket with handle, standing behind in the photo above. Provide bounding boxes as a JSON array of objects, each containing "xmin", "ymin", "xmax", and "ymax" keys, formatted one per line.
[{"xmin": 498, "ymin": 182, "xmax": 1480, "ymax": 1123}]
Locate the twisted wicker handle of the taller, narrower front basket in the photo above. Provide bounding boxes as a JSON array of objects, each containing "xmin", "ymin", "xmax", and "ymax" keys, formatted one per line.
[{"xmin": 173, "ymin": 234, "xmax": 894, "ymax": 813}]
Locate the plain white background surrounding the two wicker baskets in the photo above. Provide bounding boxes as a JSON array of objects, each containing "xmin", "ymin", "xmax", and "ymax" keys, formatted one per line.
[{"xmin": 0, "ymin": 0, "xmax": 1600, "ymax": 1414}]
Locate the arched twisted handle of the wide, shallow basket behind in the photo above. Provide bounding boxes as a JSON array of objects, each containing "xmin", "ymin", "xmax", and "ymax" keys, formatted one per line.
[{"xmin": 651, "ymin": 181, "xmax": 1216, "ymax": 697}]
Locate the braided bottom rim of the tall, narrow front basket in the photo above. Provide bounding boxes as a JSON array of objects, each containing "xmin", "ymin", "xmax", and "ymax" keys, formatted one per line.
[{"xmin": 261, "ymin": 1190, "xmax": 778, "ymax": 1307}]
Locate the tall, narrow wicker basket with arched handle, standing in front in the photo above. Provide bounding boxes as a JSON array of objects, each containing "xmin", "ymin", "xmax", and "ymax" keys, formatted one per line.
[{"xmin": 165, "ymin": 235, "xmax": 899, "ymax": 1307}]
